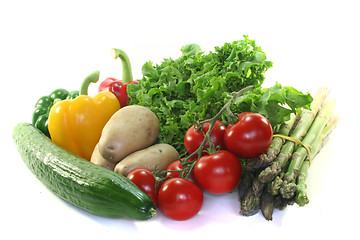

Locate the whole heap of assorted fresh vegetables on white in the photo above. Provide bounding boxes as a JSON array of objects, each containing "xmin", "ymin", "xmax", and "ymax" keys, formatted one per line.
[{"xmin": 13, "ymin": 36, "xmax": 338, "ymax": 220}]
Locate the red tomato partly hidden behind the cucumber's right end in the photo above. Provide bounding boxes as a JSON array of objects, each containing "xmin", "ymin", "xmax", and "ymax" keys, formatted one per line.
[{"xmin": 126, "ymin": 168, "xmax": 159, "ymax": 206}]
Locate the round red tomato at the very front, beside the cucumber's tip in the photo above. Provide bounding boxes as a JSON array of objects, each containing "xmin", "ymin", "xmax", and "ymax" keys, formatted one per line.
[{"xmin": 158, "ymin": 178, "xmax": 204, "ymax": 221}]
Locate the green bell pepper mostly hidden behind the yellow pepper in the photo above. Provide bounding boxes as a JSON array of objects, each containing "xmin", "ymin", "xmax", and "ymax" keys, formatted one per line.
[{"xmin": 32, "ymin": 88, "xmax": 79, "ymax": 138}]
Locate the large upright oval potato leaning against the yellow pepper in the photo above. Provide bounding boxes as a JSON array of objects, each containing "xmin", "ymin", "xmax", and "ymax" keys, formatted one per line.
[{"xmin": 98, "ymin": 105, "xmax": 160, "ymax": 163}]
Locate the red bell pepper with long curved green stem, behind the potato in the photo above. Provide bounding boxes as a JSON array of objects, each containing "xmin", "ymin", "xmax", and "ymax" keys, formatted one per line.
[{"xmin": 99, "ymin": 48, "xmax": 138, "ymax": 107}]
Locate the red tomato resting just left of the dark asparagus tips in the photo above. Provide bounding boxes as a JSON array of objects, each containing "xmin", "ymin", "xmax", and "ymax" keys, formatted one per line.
[{"xmin": 194, "ymin": 150, "xmax": 242, "ymax": 194}]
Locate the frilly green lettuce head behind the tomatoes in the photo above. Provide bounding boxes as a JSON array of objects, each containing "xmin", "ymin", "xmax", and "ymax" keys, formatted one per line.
[{"xmin": 127, "ymin": 36, "xmax": 312, "ymax": 153}]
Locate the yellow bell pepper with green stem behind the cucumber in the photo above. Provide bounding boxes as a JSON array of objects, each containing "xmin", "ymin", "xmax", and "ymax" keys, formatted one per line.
[{"xmin": 48, "ymin": 71, "xmax": 120, "ymax": 161}]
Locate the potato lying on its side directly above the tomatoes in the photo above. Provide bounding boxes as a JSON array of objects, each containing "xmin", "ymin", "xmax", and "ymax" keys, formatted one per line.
[{"xmin": 114, "ymin": 143, "xmax": 179, "ymax": 176}]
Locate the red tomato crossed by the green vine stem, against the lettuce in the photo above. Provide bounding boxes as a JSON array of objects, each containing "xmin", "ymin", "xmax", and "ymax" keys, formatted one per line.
[{"xmin": 184, "ymin": 120, "xmax": 226, "ymax": 154}]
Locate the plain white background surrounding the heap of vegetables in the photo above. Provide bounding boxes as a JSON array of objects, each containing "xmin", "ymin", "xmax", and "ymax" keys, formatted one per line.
[{"xmin": 0, "ymin": 0, "xmax": 360, "ymax": 239}]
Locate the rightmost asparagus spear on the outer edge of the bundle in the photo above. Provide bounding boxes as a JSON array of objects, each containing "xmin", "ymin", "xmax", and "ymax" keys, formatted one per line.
[{"xmin": 295, "ymin": 115, "xmax": 339, "ymax": 206}]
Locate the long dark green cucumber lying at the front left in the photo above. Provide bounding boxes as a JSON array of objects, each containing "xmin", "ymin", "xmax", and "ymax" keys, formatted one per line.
[{"xmin": 13, "ymin": 123, "xmax": 156, "ymax": 220}]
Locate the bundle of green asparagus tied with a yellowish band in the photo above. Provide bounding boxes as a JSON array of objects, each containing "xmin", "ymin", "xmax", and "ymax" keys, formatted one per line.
[{"xmin": 239, "ymin": 88, "xmax": 339, "ymax": 220}]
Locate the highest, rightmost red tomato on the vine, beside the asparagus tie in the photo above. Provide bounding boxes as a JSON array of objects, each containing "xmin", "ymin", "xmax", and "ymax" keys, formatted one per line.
[{"xmin": 224, "ymin": 112, "xmax": 273, "ymax": 158}]
